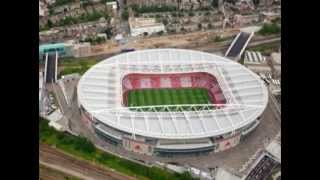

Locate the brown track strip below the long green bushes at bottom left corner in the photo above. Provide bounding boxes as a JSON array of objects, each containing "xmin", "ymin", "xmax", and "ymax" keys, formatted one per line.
[{"xmin": 39, "ymin": 144, "xmax": 136, "ymax": 180}]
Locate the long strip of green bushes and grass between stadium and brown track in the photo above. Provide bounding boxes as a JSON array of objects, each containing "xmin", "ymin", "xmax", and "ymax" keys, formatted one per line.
[{"xmin": 39, "ymin": 118, "xmax": 198, "ymax": 180}]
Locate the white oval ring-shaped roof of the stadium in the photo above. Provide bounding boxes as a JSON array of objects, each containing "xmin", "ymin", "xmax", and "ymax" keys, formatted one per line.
[{"xmin": 78, "ymin": 49, "xmax": 268, "ymax": 139}]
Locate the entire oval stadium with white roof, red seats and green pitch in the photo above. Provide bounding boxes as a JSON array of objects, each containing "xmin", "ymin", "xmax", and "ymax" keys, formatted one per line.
[{"xmin": 77, "ymin": 49, "xmax": 268, "ymax": 156}]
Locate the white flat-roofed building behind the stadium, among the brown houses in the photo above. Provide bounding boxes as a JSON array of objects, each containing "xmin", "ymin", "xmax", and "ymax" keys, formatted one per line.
[{"xmin": 129, "ymin": 17, "xmax": 165, "ymax": 36}]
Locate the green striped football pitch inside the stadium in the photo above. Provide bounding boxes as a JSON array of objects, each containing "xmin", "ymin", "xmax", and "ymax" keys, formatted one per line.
[{"xmin": 128, "ymin": 88, "xmax": 212, "ymax": 111}]
